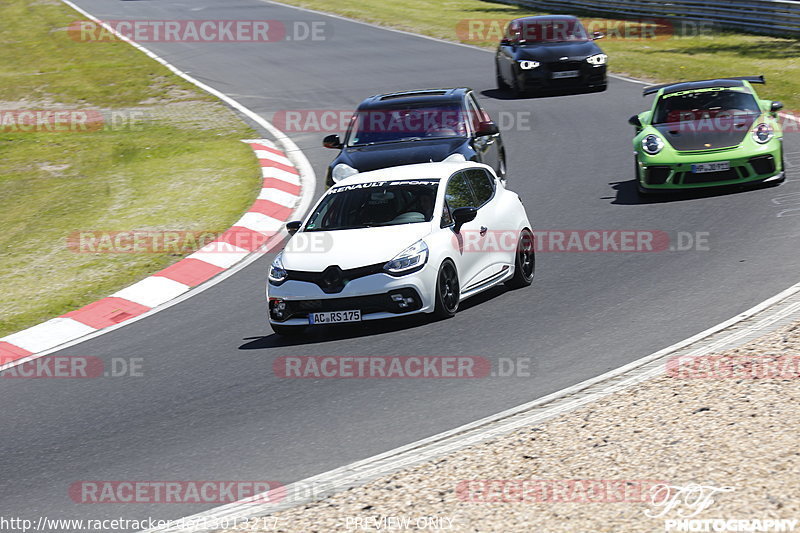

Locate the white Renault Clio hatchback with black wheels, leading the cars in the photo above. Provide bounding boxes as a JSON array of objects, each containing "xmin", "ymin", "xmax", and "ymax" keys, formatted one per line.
[{"xmin": 267, "ymin": 162, "xmax": 535, "ymax": 335}]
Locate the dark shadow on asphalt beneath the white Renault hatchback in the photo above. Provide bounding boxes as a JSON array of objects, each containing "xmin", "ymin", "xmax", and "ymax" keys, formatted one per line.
[{"xmin": 239, "ymin": 286, "xmax": 512, "ymax": 350}]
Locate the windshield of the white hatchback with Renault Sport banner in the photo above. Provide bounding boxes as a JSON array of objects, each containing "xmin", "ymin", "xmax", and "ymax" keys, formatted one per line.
[{"xmin": 305, "ymin": 180, "xmax": 439, "ymax": 231}]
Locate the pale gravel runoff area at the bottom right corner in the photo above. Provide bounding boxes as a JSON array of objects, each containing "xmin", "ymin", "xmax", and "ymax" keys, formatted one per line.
[{"xmin": 222, "ymin": 323, "xmax": 800, "ymax": 533}]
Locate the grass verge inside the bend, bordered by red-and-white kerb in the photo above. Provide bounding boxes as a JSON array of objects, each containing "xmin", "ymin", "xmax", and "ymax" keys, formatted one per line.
[{"xmin": 0, "ymin": 0, "xmax": 261, "ymax": 336}]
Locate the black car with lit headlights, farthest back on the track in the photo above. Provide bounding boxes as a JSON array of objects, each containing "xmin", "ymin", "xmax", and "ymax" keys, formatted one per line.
[{"xmin": 495, "ymin": 15, "xmax": 608, "ymax": 96}]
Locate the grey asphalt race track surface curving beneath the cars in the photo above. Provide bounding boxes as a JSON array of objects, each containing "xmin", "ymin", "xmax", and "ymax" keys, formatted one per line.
[{"xmin": 0, "ymin": 0, "xmax": 800, "ymax": 519}]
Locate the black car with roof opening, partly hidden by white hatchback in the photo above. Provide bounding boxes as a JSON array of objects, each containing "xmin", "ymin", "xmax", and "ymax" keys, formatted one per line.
[{"xmin": 322, "ymin": 87, "xmax": 506, "ymax": 187}]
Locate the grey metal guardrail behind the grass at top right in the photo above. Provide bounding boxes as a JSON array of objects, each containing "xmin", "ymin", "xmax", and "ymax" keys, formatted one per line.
[{"xmin": 501, "ymin": 0, "xmax": 800, "ymax": 38}]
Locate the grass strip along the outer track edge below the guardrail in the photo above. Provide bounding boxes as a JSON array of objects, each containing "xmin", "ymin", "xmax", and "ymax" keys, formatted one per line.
[{"xmin": 283, "ymin": 0, "xmax": 800, "ymax": 111}]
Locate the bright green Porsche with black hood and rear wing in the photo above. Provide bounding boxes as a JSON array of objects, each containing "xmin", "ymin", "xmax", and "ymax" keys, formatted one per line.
[{"xmin": 629, "ymin": 76, "xmax": 785, "ymax": 195}]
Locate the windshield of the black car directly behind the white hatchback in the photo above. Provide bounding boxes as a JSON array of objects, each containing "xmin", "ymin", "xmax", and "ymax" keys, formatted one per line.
[{"xmin": 347, "ymin": 104, "xmax": 467, "ymax": 146}]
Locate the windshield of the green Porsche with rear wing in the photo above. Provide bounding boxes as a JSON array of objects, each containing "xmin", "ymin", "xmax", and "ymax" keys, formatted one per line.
[{"xmin": 653, "ymin": 88, "xmax": 761, "ymax": 124}]
